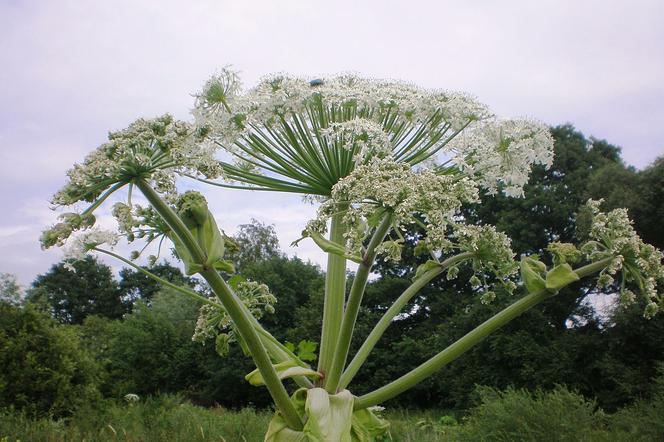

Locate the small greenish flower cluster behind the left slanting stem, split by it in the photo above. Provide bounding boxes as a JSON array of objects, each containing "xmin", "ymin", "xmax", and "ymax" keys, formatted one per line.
[{"xmin": 191, "ymin": 279, "xmax": 277, "ymax": 356}]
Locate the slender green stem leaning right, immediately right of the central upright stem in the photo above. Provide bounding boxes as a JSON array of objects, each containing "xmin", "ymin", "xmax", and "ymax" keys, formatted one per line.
[{"xmin": 325, "ymin": 213, "xmax": 392, "ymax": 394}]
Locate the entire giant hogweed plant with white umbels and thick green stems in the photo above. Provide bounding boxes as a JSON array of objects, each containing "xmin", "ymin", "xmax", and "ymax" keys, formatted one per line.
[{"xmin": 41, "ymin": 69, "xmax": 664, "ymax": 441}]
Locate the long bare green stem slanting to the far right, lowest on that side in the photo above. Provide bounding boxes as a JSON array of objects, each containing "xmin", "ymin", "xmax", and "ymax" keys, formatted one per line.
[{"xmin": 354, "ymin": 258, "xmax": 613, "ymax": 410}]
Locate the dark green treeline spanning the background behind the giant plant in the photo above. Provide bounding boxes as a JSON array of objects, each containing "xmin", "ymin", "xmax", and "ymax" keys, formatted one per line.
[{"xmin": 0, "ymin": 125, "xmax": 664, "ymax": 415}]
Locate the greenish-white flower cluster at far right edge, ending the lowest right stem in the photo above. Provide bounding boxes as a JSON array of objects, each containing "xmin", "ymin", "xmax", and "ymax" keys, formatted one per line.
[{"xmin": 581, "ymin": 200, "xmax": 664, "ymax": 317}]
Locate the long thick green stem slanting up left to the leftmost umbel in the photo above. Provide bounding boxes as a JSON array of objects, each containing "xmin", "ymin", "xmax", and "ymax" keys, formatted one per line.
[{"xmin": 136, "ymin": 180, "xmax": 302, "ymax": 430}]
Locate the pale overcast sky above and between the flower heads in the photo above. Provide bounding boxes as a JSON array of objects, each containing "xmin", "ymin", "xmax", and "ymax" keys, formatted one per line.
[{"xmin": 0, "ymin": 0, "xmax": 664, "ymax": 285}]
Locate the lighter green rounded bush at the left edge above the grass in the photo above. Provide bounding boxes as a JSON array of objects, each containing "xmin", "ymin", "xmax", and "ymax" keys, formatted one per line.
[{"xmin": 0, "ymin": 303, "xmax": 99, "ymax": 416}]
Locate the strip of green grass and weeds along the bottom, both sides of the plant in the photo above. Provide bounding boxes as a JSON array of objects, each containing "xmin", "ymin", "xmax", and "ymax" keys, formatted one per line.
[{"xmin": 0, "ymin": 387, "xmax": 664, "ymax": 442}]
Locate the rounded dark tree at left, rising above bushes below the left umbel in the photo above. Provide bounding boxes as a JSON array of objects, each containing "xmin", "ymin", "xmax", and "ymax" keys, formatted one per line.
[{"xmin": 28, "ymin": 257, "xmax": 129, "ymax": 324}]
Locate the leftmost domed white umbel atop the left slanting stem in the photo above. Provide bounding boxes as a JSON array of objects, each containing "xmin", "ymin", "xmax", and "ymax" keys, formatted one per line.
[{"xmin": 41, "ymin": 115, "xmax": 221, "ymax": 252}]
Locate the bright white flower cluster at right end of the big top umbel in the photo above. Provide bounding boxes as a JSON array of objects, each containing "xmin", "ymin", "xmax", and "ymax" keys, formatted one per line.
[{"xmin": 451, "ymin": 120, "xmax": 553, "ymax": 196}]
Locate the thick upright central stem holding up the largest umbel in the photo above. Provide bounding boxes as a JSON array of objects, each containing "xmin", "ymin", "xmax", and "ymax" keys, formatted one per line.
[{"xmin": 318, "ymin": 211, "xmax": 346, "ymax": 376}]
